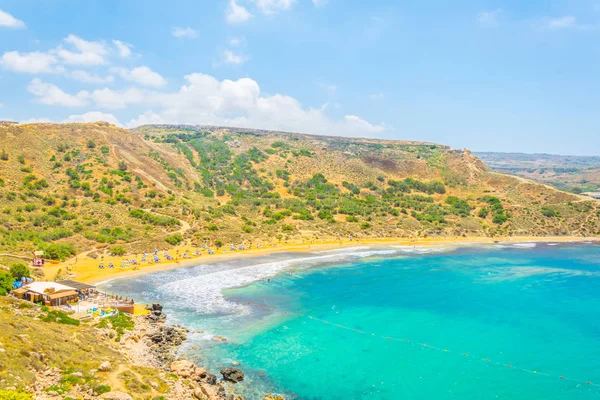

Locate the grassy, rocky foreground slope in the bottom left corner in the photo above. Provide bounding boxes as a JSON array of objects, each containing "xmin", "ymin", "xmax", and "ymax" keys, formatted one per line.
[{"xmin": 0, "ymin": 296, "xmax": 246, "ymax": 400}]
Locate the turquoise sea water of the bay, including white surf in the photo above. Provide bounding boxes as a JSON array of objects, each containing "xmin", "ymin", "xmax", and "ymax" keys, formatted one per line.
[{"xmin": 106, "ymin": 244, "xmax": 600, "ymax": 400}]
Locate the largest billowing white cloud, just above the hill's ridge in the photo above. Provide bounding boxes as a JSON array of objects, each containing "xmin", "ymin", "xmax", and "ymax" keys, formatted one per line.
[{"xmin": 115, "ymin": 73, "xmax": 386, "ymax": 136}]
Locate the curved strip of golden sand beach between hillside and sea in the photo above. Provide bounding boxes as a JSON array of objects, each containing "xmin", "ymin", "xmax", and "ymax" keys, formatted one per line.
[{"xmin": 42, "ymin": 236, "xmax": 600, "ymax": 285}]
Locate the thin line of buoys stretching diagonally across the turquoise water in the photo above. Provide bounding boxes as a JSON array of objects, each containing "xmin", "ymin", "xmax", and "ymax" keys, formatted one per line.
[{"xmin": 223, "ymin": 297, "xmax": 600, "ymax": 387}]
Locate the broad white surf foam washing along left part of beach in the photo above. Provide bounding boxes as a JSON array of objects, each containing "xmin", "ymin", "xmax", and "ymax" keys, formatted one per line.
[{"xmin": 157, "ymin": 249, "xmax": 398, "ymax": 314}]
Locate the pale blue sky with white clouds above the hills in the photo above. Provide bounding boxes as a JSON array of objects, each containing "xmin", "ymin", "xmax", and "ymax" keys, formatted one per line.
[{"xmin": 0, "ymin": 0, "xmax": 600, "ymax": 155}]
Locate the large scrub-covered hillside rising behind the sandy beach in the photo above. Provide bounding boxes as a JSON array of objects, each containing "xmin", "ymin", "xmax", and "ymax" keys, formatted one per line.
[{"xmin": 0, "ymin": 123, "xmax": 600, "ymax": 263}]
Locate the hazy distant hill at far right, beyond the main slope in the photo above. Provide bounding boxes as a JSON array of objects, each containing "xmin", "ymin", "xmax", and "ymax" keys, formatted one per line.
[{"xmin": 474, "ymin": 153, "xmax": 600, "ymax": 193}]
